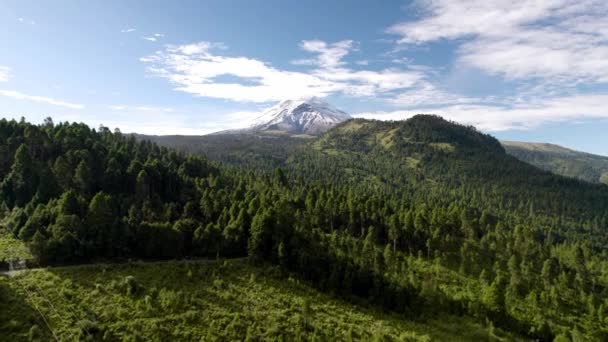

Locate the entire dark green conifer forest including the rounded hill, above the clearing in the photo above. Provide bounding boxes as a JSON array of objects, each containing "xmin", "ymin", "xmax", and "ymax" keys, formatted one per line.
[{"xmin": 0, "ymin": 116, "xmax": 608, "ymax": 340}]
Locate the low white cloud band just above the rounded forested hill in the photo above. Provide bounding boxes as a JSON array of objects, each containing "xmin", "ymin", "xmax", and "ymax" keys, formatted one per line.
[{"xmin": 353, "ymin": 94, "xmax": 608, "ymax": 131}]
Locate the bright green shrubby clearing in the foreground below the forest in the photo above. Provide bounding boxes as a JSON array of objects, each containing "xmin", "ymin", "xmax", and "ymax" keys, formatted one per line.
[{"xmin": 0, "ymin": 261, "xmax": 524, "ymax": 341}]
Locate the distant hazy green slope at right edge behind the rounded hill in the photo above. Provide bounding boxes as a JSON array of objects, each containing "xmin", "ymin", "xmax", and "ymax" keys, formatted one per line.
[{"xmin": 501, "ymin": 141, "xmax": 608, "ymax": 184}]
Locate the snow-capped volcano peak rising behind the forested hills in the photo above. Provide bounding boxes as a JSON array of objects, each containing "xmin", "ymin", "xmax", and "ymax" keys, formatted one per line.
[{"xmin": 250, "ymin": 97, "xmax": 351, "ymax": 135}]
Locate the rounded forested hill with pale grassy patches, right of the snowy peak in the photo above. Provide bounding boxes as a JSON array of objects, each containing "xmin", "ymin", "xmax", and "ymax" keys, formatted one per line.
[{"xmin": 288, "ymin": 115, "xmax": 608, "ymax": 246}]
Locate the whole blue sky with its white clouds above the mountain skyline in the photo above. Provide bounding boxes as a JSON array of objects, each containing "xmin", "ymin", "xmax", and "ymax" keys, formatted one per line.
[{"xmin": 0, "ymin": 0, "xmax": 608, "ymax": 155}]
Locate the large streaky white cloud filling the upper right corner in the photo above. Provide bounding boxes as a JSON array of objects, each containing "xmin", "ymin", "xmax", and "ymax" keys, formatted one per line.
[{"xmin": 388, "ymin": 0, "xmax": 608, "ymax": 85}]
